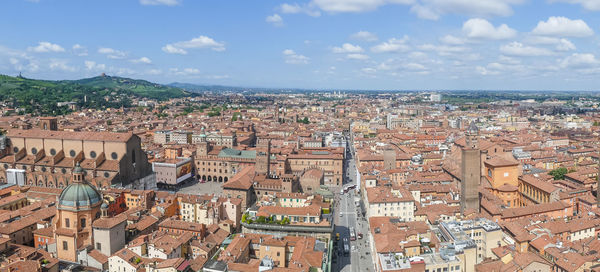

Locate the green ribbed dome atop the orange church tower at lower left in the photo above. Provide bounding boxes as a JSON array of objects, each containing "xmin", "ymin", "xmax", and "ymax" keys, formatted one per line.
[{"xmin": 58, "ymin": 182, "xmax": 102, "ymax": 210}]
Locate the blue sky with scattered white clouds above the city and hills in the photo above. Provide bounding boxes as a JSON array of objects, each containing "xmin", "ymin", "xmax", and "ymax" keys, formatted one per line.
[{"xmin": 0, "ymin": 0, "xmax": 600, "ymax": 90}]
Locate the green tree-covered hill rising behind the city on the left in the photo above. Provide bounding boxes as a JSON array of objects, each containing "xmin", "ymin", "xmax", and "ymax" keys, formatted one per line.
[{"xmin": 0, "ymin": 75, "xmax": 190, "ymax": 115}]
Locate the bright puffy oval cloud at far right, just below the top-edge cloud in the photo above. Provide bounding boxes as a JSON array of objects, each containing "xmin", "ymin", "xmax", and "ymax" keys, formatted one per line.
[{"xmin": 532, "ymin": 17, "xmax": 594, "ymax": 37}]
